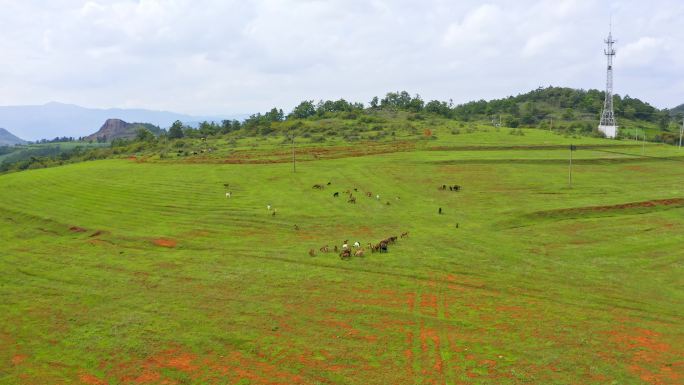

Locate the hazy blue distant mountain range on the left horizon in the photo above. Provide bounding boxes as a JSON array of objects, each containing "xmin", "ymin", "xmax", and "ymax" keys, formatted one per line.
[{"xmin": 0, "ymin": 102, "xmax": 248, "ymax": 140}]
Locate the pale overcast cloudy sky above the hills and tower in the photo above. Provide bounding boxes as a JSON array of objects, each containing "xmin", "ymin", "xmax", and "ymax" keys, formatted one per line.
[{"xmin": 0, "ymin": 0, "xmax": 684, "ymax": 114}]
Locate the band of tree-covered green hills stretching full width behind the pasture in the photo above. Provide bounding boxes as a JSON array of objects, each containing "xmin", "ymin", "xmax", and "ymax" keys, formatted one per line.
[{"xmin": 0, "ymin": 87, "xmax": 682, "ymax": 172}]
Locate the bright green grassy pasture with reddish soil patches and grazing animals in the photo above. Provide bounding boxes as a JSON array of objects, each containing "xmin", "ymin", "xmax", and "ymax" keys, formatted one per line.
[{"xmin": 0, "ymin": 127, "xmax": 684, "ymax": 385}]
